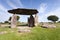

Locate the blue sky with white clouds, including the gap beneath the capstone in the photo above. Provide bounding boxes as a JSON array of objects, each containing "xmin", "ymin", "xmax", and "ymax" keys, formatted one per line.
[{"xmin": 0, "ymin": 0, "xmax": 60, "ymax": 22}]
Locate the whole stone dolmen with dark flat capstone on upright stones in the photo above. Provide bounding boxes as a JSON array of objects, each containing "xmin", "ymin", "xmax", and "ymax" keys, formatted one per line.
[{"xmin": 8, "ymin": 8, "xmax": 38, "ymax": 28}]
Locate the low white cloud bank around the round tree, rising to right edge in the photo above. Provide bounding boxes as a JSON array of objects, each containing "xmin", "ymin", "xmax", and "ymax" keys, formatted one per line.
[{"xmin": 39, "ymin": 7, "xmax": 60, "ymax": 22}]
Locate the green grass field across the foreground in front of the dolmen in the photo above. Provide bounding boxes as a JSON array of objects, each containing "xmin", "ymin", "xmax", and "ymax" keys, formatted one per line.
[{"xmin": 0, "ymin": 23, "xmax": 60, "ymax": 40}]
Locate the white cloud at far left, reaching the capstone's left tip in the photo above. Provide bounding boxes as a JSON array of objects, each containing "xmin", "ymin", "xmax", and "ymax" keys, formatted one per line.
[{"xmin": 0, "ymin": 4, "xmax": 11, "ymax": 22}]
